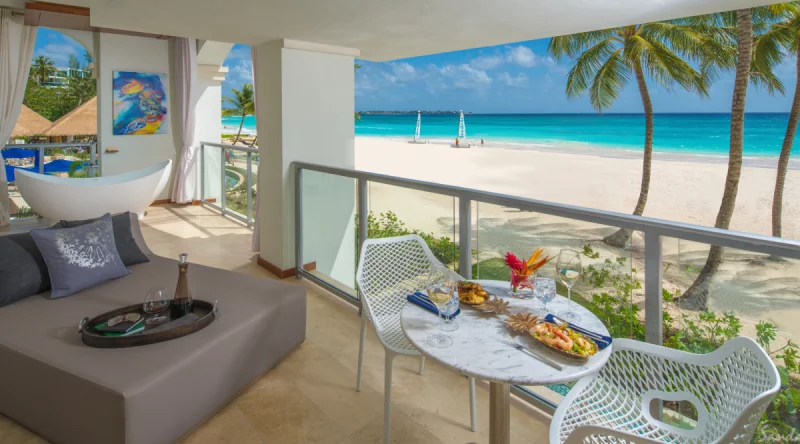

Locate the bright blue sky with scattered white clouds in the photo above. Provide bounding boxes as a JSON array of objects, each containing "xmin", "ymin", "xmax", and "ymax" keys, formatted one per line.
[{"xmin": 34, "ymin": 28, "xmax": 796, "ymax": 113}]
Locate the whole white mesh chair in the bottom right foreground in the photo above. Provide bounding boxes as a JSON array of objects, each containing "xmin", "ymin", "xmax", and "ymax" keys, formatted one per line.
[{"xmin": 550, "ymin": 337, "xmax": 780, "ymax": 444}]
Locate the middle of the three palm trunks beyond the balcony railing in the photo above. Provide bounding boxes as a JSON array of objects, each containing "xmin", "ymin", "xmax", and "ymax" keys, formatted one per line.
[{"xmin": 680, "ymin": 9, "xmax": 753, "ymax": 310}]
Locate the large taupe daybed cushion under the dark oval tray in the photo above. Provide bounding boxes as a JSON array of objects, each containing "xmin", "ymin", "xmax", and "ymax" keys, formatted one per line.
[{"xmin": 0, "ymin": 256, "xmax": 306, "ymax": 444}]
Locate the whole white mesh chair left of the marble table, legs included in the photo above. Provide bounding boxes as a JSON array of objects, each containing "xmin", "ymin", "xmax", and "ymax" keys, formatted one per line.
[{"xmin": 356, "ymin": 234, "xmax": 476, "ymax": 444}]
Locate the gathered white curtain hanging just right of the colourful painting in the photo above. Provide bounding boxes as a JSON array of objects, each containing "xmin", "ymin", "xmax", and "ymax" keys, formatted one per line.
[{"xmin": 172, "ymin": 38, "xmax": 198, "ymax": 203}]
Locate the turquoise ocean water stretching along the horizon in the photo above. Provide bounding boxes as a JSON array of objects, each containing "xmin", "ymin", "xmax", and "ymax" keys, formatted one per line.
[{"xmin": 223, "ymin": 113, "xmax": 800, "ymax": 157}]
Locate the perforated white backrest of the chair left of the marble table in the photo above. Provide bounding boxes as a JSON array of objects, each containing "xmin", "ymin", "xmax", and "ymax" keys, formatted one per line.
[{"xmin": 356, "ymin": 234, "xmax": 440, "ymax": 347}]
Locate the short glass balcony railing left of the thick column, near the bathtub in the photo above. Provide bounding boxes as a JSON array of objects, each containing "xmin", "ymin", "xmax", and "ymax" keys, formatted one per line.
[{"xmin": 200, "ymin": 142, "xmax": 260, "ymax": 227}]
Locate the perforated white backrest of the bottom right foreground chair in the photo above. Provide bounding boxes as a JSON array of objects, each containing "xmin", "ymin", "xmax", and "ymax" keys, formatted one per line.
[{"xmin": 599, "ymin": 337, "xmax": 780, "ymax": 443}]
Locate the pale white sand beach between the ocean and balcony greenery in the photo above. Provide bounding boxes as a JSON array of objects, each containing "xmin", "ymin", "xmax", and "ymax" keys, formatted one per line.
[{"xmin": 355, "ymin": 137, "xmax": 800, "ymax": 338}]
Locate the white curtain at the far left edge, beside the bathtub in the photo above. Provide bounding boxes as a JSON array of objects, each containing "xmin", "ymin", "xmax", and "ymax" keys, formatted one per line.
[{"xmin": 0, "ymin": 9, "xmax": 38, "ymax": 226}]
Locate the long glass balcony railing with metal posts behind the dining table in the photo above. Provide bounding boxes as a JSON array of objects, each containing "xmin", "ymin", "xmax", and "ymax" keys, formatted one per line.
[{"xmin": 294, "ymin": 162, "xmax": 800, "ymax": 442}]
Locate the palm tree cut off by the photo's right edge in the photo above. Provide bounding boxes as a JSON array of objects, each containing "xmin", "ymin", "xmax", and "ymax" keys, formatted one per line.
[{"xmin": 753, "ymin": 2, "xmax": 800, "ymax": 246}]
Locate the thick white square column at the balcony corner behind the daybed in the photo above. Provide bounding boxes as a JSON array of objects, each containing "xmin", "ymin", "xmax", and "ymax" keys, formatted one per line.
[{"xmin": 255, "ymin": 40, "xmax": 358, "ymax": 284}]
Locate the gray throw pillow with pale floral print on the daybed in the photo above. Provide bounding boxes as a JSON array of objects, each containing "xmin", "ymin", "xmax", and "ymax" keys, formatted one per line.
[{"xmin": 31, "ymin": 215, "xmax": 131, "ymax": 299}]
